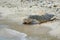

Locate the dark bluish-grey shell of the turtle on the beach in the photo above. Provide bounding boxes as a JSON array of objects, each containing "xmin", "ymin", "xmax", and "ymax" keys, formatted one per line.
[{"xmin": 28, "ymin": 14, "xmax": 54, "ymax": 22}]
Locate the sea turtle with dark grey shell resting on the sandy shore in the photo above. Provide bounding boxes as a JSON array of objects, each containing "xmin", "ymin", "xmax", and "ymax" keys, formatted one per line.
[{"xmin": 23, "ymin": 13, "xmax": 56, "ymax": 24}]
